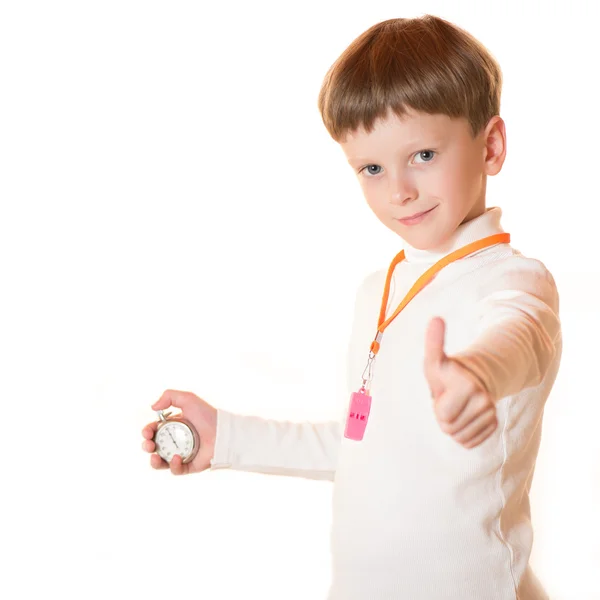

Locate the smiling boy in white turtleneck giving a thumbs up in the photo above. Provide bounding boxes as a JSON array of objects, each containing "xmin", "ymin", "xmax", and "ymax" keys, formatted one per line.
[{"xmin": 143, "ymin": 15, "xmax": 562, "ymax": 600}]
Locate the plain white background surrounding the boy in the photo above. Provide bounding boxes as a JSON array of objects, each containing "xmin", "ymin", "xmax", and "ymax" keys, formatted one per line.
[{"xmin": 0, "ymin": 0, "xmax": 600, "ymax": 600}]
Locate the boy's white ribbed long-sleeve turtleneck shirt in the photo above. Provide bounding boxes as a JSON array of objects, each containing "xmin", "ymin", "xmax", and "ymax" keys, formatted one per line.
[{"xmin": 211, "ymin": 207, "xmax": 562, "ymax": 600}]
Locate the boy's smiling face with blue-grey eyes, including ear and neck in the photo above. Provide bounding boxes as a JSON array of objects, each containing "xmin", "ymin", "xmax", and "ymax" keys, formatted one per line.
[{"xmin": 340, "ymin": 111, "xmax": 506, "ymax": 250}]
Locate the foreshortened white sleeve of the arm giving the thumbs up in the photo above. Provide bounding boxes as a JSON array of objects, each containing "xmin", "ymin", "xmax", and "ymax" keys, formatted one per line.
[{"xmin": 451, "ymin": 255, "xmax": 562, "ymax": 402}]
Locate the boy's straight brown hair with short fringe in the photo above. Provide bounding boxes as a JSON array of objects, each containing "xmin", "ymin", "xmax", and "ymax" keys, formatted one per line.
[{"xmin": 318, "ymin": 15, "xmax": 502, "ymax": 142}]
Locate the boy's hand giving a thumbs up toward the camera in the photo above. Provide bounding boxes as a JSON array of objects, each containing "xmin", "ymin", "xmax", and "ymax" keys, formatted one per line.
[{"xmin": 424, "ymin": 317, "xmax": 498, "ymax": 448}]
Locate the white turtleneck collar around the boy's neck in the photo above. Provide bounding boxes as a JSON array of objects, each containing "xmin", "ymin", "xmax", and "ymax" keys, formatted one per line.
[{"xmin": 404, "ymin": 206, "xmax": 504, "ymax": 264}]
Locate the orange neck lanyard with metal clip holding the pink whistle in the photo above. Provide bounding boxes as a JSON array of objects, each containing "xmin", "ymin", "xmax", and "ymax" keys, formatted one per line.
[{"xmin": 363, "ymin": 233, "xmax": 510, "ymax": 390}]
